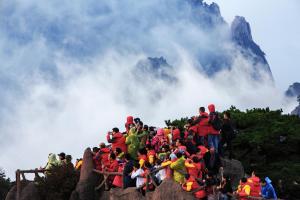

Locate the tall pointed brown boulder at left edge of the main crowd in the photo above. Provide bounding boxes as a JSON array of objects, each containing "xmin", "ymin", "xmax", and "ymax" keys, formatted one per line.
[{"xmin": 70, "ymin": 148, "xmax": 100, "ymax": 200}]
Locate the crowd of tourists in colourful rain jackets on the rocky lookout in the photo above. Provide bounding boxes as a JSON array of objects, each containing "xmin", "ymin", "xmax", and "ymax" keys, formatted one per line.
[{"xmin": 46, "ymin": 104, "xmax": 277, "ymax": 200}]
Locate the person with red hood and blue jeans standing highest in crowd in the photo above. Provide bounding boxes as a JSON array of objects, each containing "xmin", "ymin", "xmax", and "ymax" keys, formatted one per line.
[{"xmin": 208, "ymin": 104, "xmax": 221, "ymax": 152}]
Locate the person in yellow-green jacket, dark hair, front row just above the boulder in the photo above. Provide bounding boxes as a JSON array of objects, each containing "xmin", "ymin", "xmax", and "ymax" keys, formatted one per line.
[{"xmin": 170, "ymin": 152, "xmax": 186, "ymax": 184}]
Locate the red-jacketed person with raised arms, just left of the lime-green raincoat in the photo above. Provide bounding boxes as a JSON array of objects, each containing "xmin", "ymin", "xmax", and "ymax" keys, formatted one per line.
[{"xmin": 106, "ymin": 128, "xmax": 127, "ymax": 153}]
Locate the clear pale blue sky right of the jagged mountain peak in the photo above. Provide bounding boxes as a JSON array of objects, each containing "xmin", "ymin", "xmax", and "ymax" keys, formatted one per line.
[{"xmin": 206, "ymin": 0, "xmax": 300, "ymax": 91}]
